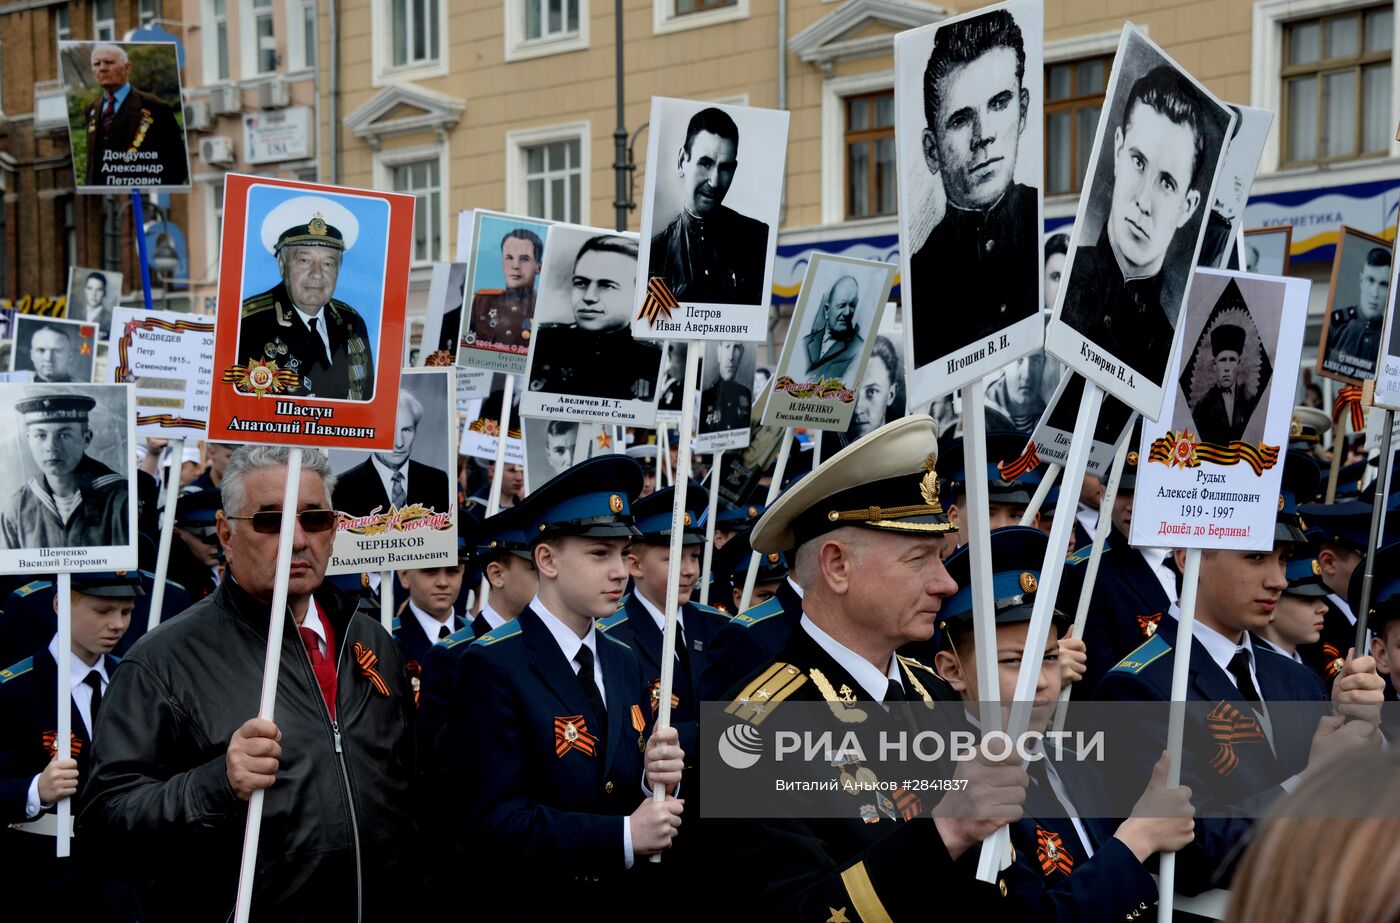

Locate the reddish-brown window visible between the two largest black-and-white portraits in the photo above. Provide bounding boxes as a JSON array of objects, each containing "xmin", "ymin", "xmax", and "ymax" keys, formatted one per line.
[{"xmin": 1046, "ymin": 55, "xmax": 1113, "ymax": 195}]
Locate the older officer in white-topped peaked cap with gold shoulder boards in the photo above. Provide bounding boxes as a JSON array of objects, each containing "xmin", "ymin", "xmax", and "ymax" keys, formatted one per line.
[{"xmin": 700, "ymin": 416, "xmax": 1026, "ymax": 923}]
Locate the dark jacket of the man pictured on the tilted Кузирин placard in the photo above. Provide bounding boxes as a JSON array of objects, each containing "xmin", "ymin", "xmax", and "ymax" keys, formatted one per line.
[{"xmin": 1061, "ymin": 227, "xmax": 1176, "ymax": 381}]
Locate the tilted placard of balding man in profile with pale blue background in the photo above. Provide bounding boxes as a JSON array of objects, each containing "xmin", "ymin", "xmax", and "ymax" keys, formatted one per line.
[{"xmin": 761, "ymin": 254, "xmax": 896, "ymax": 430}]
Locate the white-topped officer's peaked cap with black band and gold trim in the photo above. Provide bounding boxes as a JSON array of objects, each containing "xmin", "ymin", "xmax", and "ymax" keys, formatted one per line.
[{"xmin": 750, "ymin": 415, "xmax": 958, "ymax": 555}]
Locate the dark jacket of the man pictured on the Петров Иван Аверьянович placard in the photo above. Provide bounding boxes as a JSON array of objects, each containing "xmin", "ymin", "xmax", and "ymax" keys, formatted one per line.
[{"xmin": 647, "ymin": 204, "xmax": 769, "ymax": 304}]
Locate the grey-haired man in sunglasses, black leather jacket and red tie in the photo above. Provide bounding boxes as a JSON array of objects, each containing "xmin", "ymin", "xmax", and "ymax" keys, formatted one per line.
[{"xmin": 77, "ymin": 445, "xmax": 423, "ymax": 923}]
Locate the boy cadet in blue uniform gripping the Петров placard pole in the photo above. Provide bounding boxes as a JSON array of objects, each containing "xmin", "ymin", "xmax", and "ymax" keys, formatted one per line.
[{"xmin": 444, "ymin": 455, "xmax": 683, "ymax": 919}]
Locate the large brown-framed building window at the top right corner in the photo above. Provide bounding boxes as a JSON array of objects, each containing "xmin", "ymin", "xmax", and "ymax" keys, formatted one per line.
[{"xmin": 1281, "ymin": 4, "xmax": 1394, "ymax": 167}]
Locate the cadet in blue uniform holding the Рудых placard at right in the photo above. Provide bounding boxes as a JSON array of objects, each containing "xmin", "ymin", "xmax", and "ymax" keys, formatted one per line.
[{"xmin": 1095, "ymin": 452, "xmax": 1383, "ymax": 894}]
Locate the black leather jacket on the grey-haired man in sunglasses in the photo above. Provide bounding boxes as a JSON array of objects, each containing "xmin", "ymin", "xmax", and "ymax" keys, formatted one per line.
[{"xmin": 78, "ymin": 578, "xmax": 421, "ymax": 923}]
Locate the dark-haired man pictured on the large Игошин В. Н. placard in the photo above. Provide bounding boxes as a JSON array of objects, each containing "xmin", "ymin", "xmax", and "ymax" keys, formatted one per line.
[{"xmin": 909, "ymin": 10, "xmax": 1042, "ymax": 366}]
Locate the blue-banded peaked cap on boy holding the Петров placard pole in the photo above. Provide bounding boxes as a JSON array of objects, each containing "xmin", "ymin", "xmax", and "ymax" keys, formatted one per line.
[{"xmin": 526, "ymin": 455, "xmax": 643, "ymax": 541}]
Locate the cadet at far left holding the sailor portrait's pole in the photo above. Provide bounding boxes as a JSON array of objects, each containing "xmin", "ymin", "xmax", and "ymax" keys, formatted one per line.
[{"xmin": 0, "ymin": 571, "xmax": 144, "ymax": 919}]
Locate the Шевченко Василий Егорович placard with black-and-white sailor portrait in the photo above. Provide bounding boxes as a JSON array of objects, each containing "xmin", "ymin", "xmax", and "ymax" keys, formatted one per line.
[{"xmin": 0, "ymin": 384, "xmax": 137, "ymax": 574}]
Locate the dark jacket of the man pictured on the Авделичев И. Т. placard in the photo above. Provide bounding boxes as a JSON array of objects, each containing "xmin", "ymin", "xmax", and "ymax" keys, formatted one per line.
[{"xmin": 529, "ymin": 324, "xmax": 661, "ymax": 401}]
